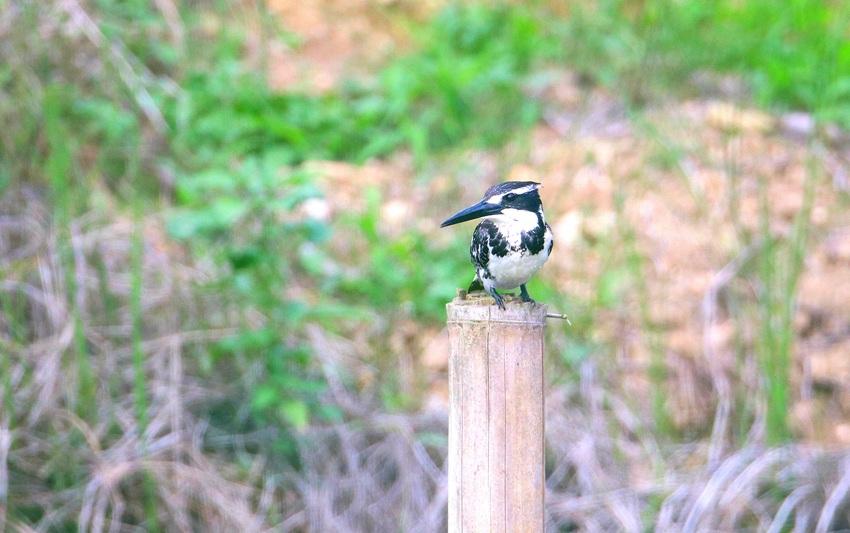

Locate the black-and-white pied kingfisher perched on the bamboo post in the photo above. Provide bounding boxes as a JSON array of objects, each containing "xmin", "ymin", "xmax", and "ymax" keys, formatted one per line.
[{"xmin": 440, "ymin": 181, "xmax": 554, "ymax": 310}]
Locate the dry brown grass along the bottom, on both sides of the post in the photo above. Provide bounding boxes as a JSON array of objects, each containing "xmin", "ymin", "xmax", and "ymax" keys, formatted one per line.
[{"xmin": 0, "ymin": 178, "xmax": 850, "ymax": 532}]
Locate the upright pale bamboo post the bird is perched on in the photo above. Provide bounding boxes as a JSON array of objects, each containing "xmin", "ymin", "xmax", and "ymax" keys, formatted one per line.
[{"xmin": 446, "ymin": 291, "xmax": 547, "ymax": 533}]
